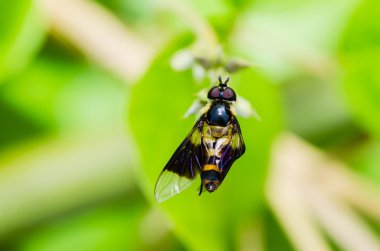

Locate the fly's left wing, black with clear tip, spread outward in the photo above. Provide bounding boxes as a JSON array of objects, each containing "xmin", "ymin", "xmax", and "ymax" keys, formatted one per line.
[{"xmin": 154, "ymin": 116, "xmax": 205, "ymax": 202}]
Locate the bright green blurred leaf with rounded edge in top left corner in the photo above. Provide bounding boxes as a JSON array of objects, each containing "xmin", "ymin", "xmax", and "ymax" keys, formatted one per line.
[{"xmin": 0, "ymin": 0, "xmax": 45, "ymax": 83}]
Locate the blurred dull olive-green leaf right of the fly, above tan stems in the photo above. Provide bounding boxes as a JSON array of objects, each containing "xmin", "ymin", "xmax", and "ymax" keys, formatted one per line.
[{"xmin": 282, "ymin": 76, "xmax": 355, "ymax": 147}]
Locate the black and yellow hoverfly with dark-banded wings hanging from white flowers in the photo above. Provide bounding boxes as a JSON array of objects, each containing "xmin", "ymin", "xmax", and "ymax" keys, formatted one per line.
[{"xmin": 154, "ymin": 77, "xmax": 245, "ymax": 202}]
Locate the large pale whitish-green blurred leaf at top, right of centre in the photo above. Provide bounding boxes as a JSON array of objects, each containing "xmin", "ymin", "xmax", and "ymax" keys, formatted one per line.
[{"xmin": 229, "ymin": 0, "xmax": 358, "ymax": 80}]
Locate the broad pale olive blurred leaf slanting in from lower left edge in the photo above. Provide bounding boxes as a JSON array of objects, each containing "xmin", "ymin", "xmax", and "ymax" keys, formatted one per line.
[{"xmin": 0, "ymin": 130, "xmax": 137, "ymax": 239}]
